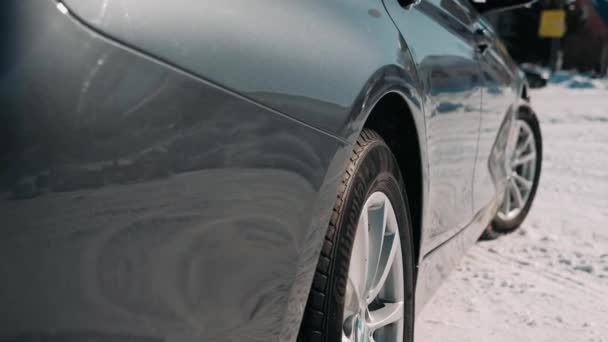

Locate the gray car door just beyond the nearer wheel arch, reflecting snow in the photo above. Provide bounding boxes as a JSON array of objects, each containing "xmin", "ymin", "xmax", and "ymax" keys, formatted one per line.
[{"xmin": 385, "ymin": 0, "xmax": 481, "ymax": 253}]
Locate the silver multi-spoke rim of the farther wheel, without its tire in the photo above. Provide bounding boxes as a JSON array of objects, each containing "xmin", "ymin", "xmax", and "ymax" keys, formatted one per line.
[{"xmin": 498, "ymin": 119, "xmax": 537, "ymax": 220}]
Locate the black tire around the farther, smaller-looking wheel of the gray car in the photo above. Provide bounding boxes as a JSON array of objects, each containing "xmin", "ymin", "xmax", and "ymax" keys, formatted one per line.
[{"xmin": 482, "ymin": 111, "xmax": 543, "ymax": 240}]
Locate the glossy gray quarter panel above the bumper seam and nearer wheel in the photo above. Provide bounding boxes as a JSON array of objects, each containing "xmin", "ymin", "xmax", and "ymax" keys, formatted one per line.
[{"xmin": 63, "ymin": 0, "xmax": 422, "ymax": 141}]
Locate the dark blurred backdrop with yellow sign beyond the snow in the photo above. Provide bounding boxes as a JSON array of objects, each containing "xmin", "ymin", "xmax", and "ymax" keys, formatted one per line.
[{"xmin": 487, "ymin": 0, "xmax": 608, "ymax": 77}]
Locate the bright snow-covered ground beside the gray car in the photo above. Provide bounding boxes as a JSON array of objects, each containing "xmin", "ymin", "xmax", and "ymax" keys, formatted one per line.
[{"xmin": 416, "ymin": 75, "xmax": 608, "ymax": 342}]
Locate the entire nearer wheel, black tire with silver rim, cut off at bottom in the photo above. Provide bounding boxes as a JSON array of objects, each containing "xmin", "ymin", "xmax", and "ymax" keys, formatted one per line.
[{"xmin": 300, "ymin": 130, "xmax": 414, "ymax": 342}]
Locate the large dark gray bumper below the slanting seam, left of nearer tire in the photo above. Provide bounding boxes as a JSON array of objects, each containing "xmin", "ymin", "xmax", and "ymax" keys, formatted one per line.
[{"xmin": 0, "ymin": 1, "xmax": 350, "ymax": 341}]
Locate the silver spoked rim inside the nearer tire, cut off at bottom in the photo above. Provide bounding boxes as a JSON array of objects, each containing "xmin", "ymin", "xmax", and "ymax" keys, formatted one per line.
[{"xmin": 342, "ymin": 192, "xmax": 404, "ymax": 342}]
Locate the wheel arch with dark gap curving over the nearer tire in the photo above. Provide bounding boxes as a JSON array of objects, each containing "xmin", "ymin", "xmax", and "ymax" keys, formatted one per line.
[{"xmin": 342, "ymin": 65, "xmax": 429, "ymax": 263}]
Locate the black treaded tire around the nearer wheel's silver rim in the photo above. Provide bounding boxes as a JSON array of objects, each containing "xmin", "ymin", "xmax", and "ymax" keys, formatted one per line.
[{"xmin": 298, "ymin": 129, "xmax": 415, "ymax": 342}]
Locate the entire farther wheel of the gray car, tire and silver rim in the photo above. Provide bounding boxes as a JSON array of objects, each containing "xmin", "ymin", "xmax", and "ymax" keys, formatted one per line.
[{"xmin": 485, "ymin": 112, "xmax": 542, "ymax": 238}]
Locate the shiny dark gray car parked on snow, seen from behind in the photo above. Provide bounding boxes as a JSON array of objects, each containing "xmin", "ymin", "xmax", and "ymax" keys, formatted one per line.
[{"xmin": 0, "ymin": 0, "xmax": 542, "ymax": 342}]
